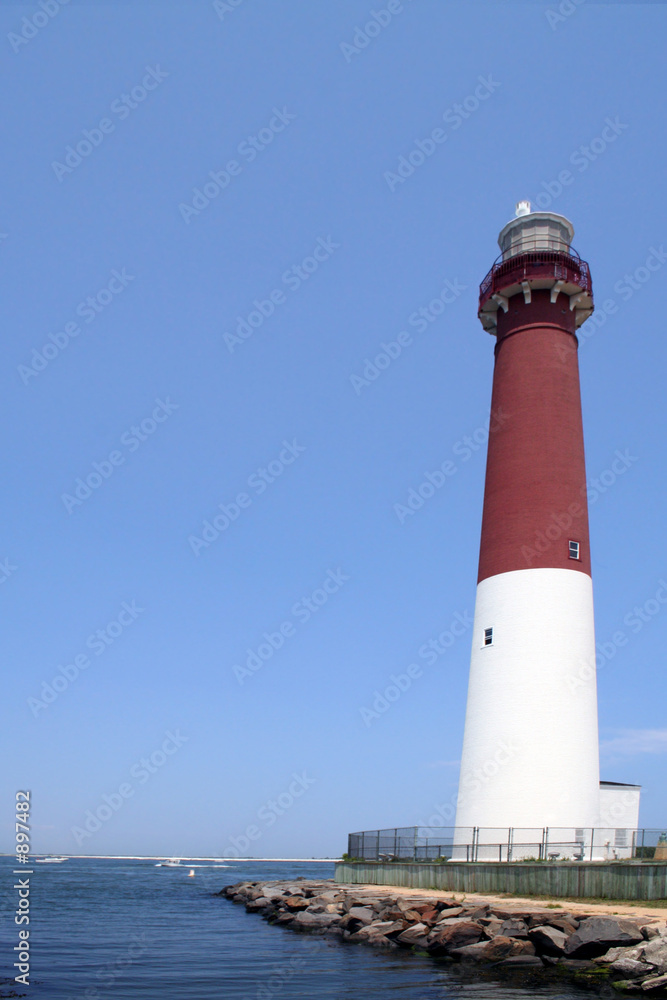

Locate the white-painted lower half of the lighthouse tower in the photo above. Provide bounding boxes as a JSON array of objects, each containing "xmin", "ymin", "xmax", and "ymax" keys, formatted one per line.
[{"xmin": 453, "ymin": 569, "xmax": 600, "ymax": 860}]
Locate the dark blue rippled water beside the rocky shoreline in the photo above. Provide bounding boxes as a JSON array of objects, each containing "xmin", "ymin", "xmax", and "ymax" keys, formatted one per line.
[{"xmin": 0, "ymin": 858, "xmax": 584, "ymax": 1000}]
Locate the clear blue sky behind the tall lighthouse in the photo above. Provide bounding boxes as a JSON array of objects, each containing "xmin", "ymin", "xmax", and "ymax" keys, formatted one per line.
[{"xmin": 0, "ymin": 0, "xmax": 667, "ymax": 857}]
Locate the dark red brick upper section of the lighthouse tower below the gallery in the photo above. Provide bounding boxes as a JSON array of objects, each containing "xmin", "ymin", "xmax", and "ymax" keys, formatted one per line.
[{"xmin": 479, "ymin": 291, "xmax": 591, "ymax": 581}]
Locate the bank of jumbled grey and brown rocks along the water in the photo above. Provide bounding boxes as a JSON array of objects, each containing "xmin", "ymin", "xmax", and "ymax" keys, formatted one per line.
[{"xmin": 218, "ymin": 878, "xmax": 667, "ymax": 997}]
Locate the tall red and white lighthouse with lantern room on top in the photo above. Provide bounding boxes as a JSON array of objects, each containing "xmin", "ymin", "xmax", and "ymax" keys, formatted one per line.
[{"xmin": 454, "ymin": 202, "xmax": 604, "ymax": 860}]
